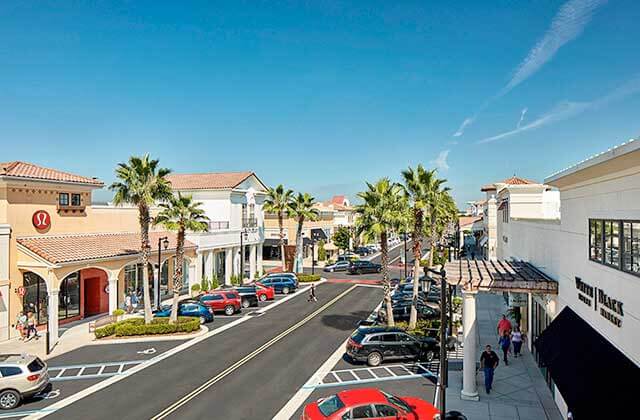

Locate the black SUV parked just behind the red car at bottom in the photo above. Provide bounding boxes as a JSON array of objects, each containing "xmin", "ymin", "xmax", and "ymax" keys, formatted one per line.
[{"xmin": 347, "ymin": 327, "xmax": 440, "ymax": 366}]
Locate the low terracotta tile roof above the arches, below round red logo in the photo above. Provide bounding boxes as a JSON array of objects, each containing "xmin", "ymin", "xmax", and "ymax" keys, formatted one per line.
[{"xmin": 17, "ymin": 232, "xmax": 195, "ymax": 264}]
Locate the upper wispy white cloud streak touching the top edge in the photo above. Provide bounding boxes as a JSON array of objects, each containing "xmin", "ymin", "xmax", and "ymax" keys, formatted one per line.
[{"xmin": 498, "ymin": 0, "xmax": 607, "ymax": 96}]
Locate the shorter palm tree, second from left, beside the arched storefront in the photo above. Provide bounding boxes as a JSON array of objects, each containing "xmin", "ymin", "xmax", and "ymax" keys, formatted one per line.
[{"xmin": 153, "ymin": 193, "xmax": 209, "ymax": 323}]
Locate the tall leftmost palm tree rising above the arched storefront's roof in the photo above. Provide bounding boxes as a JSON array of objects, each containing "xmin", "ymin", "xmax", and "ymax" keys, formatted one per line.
[{"xmin": 109, "ymin": 155, "xmax": 171, "ymax": 324}]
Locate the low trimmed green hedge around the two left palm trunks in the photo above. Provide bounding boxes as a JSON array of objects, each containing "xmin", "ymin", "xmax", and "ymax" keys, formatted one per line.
[{"xmin": 95, "ymin": 317, "xmax": 200, "ymax": 338}]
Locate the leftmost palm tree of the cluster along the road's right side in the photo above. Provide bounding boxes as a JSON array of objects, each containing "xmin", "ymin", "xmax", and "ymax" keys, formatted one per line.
[{"xmin": 356, "ymin": 178, "xmax": 403, "ymax": 327}]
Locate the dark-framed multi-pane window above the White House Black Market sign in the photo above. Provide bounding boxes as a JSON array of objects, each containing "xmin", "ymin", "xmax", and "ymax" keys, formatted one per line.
[{"xmin": 589, "ymin": 219, "xmax": 640, "ymax": 276}]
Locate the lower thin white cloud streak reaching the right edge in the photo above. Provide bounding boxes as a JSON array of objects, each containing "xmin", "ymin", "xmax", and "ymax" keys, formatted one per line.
[{"xmin": 478, "ymin": 74, "xmax": 640, "ymax": 143}]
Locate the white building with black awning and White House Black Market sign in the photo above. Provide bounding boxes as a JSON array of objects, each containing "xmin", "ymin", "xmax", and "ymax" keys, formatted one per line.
[{"xmin": 496, "ymin": 140, "xmax": 640, "ymax": 419}]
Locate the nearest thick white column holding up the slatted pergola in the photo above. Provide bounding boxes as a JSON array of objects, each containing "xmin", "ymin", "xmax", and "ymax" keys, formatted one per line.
[{"xmin": 460, "ymin": 290, "xmax": 479, "ymax": 401}]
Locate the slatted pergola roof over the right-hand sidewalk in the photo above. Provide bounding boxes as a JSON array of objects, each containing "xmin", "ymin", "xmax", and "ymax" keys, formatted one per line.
[{"xmin": 444, "ymin": 258, "xmax": 558, "ymax": 295}]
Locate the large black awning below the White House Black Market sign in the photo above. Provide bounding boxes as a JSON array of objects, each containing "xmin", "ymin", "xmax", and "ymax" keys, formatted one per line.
[{"xmin": 535, "ymin": 307, "xmax": 640, "ymax": 420}]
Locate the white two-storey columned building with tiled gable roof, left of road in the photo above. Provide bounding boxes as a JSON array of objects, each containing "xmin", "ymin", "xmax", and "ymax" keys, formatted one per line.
[{"xmin": 169, "ymin": 172, "xmax": 267, "ymax": 284}]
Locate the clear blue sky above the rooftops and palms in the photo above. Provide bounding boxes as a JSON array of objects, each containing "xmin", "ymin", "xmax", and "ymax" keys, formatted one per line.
[{"xmin": 0, "ymin": 0, "xmax": 640, "ymax": 204}]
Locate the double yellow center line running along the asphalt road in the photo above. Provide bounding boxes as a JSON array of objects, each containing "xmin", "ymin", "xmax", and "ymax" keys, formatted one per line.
[{"xmin": 151, "ymin": 284, "xmax": 358, "ymax": 420}]
